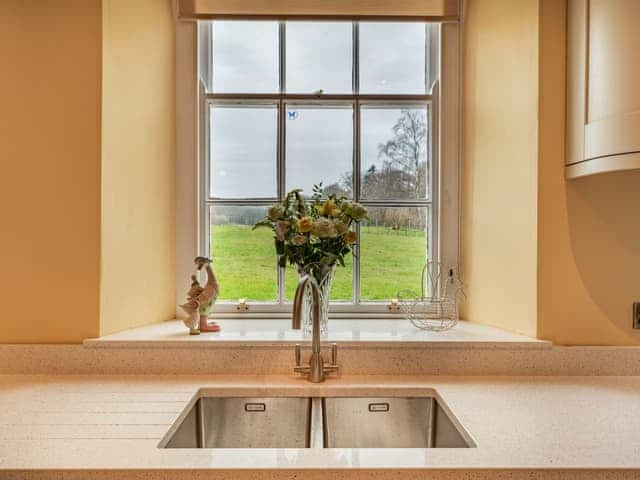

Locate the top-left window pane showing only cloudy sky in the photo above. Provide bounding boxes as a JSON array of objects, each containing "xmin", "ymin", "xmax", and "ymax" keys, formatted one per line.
[{"xmin": 213, "ymin": 21, "xmax": 280, "ymax": 93}]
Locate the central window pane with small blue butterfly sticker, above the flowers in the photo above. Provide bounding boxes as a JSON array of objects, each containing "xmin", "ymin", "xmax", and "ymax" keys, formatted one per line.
[{"xmin": 286, "ymin": 105, "xmax": 353, "ymax": 196}]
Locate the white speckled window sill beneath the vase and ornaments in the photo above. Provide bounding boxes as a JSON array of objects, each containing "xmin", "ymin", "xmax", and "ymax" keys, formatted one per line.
[{"xmin": 84, "ymin": 319, "xmax": 552, "ymax": 349}]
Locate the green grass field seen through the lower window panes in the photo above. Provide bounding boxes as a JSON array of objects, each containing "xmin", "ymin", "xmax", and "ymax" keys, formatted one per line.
[{"xmin": 211, "ymin": 224, "xmax": 426, "ymax": 301}]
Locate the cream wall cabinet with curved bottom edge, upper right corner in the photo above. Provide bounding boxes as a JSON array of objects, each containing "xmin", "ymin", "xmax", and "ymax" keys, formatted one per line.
[{"xmin": 566, "ymin": 0, "xmax": 640, "ymax": 178}]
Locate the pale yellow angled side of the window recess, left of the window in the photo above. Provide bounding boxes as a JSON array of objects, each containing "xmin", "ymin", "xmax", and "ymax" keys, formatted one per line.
[{"xmin": 100, "ymin": 0, "xmax": 175, "ymax": 335}]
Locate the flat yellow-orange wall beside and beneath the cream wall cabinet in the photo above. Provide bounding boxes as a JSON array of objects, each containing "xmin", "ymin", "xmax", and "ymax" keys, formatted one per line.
[{"xmin": 538, "ymin": 0, "xmax": 640, "ymax": 345}]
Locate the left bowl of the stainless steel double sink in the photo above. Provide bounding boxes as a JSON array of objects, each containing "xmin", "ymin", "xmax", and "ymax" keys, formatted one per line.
[{"xmin": 161, "ymin": 397, "xmax": 311, "ymax": 448}]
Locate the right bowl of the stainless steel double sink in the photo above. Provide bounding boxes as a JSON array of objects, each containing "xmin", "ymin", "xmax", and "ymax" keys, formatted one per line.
[{"xmin": 323, "ymin": 397, "xmax": 470, "ymax": 448}]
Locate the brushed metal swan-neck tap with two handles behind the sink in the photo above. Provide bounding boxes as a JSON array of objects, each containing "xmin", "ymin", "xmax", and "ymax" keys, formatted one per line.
[{"xmin": 291, "ymin": 274, "xmax": 340, "ymax": 383}]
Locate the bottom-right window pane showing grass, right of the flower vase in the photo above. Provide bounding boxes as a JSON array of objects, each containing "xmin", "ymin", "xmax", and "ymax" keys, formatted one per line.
[{"xmin": 360, "ymin": 207, "xmax": 428, "ymax": 301}]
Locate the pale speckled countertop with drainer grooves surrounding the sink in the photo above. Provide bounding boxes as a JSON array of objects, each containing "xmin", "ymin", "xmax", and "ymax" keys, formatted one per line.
[{"xmin": 0, "ymin": 375, "xmax": 640, "ymax": 478}]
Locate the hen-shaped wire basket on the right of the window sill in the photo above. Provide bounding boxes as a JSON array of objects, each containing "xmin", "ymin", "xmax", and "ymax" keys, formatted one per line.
[{"xmin": 398, "ymin": 262, "xmax": 464, "ymax": 332}]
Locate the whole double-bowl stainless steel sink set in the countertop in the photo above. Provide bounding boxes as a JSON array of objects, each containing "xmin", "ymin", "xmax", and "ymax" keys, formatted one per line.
[{"xmin": 159, "ymin": 397, "xmax": 475, "ymax": 448}]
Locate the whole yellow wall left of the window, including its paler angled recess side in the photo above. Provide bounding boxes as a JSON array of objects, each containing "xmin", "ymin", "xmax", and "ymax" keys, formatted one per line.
[{"xmin": 0, "ymin": 0, "xmax": 175, "ymax": 343}]
